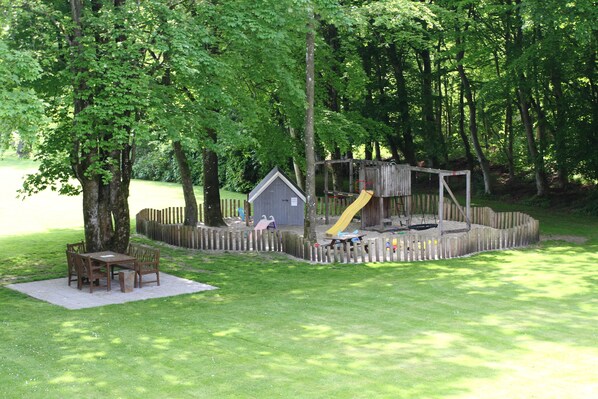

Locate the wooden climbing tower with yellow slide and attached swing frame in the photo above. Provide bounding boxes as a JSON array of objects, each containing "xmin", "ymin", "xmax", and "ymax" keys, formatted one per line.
[{"xmin": 317, "ymin": 159, "xmax": 471, "ymax": 235}]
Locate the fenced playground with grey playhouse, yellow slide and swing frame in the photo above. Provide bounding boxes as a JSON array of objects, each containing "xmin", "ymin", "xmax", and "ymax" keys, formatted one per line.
[{"xmin": 136, "ymin": 160, "xmax": 539, "ymax": 263}]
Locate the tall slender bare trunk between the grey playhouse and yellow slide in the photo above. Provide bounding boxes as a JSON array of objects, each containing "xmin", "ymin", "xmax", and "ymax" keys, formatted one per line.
[{"xmin": 303, "ymin": 5, "xmax": 317, "ymax": 243}]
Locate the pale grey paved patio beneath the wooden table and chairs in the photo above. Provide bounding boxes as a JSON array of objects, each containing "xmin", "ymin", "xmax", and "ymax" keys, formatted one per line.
[{"xmin": 6, "ymin": 273, "xmax": 217, "ymax": 309}]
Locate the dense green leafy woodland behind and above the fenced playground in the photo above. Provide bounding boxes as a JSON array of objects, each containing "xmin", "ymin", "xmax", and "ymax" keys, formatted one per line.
[{"xmin": 0, "ymin": 0, "xmax": 598, "ymax": 249}]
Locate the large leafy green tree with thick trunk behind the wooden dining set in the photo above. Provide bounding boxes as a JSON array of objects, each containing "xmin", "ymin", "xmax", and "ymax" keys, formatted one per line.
[{"xmin": 13, "ymin": 0, "xmax": 148, "ymax": 251}]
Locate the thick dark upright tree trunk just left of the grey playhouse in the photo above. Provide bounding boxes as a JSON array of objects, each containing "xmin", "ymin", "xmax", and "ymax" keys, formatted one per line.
[{"xmin": 203, "ymin": 128, "xmax": 226, "ymax": 227}]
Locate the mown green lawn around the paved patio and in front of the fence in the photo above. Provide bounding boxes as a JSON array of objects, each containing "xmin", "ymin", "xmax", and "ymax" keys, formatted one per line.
[{"xmin": 0, "ymin": 158, "xmax": 598, "ymax": 399}]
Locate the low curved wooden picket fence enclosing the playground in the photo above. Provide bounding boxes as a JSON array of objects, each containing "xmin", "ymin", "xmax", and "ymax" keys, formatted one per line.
[{"xmin": 137, "ymin": 195, "xmax": 540, "ymax": 263}]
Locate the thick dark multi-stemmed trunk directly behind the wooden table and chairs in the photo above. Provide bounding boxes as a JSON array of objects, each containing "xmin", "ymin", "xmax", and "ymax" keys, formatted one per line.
[{"xmin": 70, "ymin": 0, "xmax": 133, "ymax": 252}]
